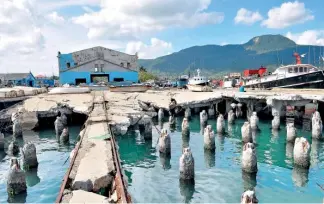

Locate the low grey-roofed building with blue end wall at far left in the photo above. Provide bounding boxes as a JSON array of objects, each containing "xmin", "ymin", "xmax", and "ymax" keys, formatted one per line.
[{"xmin": 0, "ymin": 72, "xmax": 36, "ymax": 87}]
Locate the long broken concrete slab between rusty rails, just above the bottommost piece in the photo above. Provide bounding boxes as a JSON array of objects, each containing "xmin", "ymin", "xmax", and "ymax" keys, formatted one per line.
[{"xmin": 72, "ymin": 139, "xmax": 115, "ymax": 192}]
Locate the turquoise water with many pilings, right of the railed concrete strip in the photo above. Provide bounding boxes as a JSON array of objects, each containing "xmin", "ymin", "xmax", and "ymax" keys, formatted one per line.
[{"xmin": 118, "ymin": 117, "xmax": 324, "ymax": 203}]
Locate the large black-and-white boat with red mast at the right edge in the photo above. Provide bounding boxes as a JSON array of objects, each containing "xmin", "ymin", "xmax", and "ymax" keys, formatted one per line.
[{"xmin": 244, "ymin": 53, "xmax": 324, "ymax": 88}]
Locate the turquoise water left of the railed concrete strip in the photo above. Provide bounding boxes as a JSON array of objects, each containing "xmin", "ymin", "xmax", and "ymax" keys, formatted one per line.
[{"xmin": 0, "ymin": 126, "xmax": 80, "ymax": 203}]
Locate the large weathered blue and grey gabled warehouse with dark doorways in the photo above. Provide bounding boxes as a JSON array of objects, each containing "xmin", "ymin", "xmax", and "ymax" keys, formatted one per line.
[{"xmin": 57, "ymin": 47, "xmax": 138, "ymax": 85}]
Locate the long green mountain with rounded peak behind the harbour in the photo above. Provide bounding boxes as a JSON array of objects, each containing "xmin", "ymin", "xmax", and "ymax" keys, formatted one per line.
[{"xmin": 139, "ymin": 35, "xmax": 321, "ymax": 75}]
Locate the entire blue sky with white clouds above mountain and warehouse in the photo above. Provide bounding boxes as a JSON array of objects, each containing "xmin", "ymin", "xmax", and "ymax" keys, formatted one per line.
[{"xmin": 0, "ymin": 0, "xmax": 324, "ymax": 76}]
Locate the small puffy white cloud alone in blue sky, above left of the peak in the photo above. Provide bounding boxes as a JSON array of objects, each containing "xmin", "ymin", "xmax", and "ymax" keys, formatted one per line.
[{"xmin": 234, "ymin": 8, "xmax": 263, "ymax": 25}]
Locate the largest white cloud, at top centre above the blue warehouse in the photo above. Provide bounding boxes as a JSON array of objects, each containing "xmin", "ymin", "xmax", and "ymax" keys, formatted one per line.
[{"xmin": 73, "ymin": 0, "xmax": 224, "ymax": 39}]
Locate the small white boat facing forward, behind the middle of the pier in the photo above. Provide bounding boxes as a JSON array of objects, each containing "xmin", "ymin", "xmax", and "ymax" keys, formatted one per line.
[{"xmin": 187, "ymin": 69, "xmax": 212, "ymax": 92}]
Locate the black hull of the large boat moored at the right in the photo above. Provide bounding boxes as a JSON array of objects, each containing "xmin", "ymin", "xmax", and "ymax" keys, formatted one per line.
[{"xmin": 245, "ymin": 71, "xmax": 324, "ymax": 88}]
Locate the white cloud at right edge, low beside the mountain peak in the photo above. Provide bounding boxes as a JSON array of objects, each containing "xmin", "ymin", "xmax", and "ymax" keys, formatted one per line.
[{"xmin": 286, "ymin": 30, "xmax": 324, "ymax": 45}]
